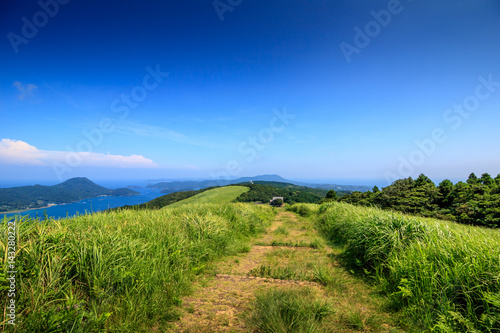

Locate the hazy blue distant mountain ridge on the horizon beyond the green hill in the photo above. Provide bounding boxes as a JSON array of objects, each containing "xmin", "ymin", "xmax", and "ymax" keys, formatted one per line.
[{"xmin": 147, "ymin": 175, "xmax": 371, "ymax": 193}]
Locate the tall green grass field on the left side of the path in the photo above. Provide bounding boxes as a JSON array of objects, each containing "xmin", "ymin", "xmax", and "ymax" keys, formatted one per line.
[{"xmin": 0, "ymin": 204, "xmax": 274, "ymax": 332}]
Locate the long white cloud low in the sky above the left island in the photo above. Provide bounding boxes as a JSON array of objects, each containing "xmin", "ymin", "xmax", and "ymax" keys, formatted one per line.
[{"xmin": 0, "ymin": 139, "xmax": 159, "ymax": 168}]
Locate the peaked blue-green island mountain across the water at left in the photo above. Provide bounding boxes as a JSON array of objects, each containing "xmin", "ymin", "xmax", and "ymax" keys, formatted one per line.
[{"xmin": 0, "ymin": 177, "xmax": 139, "ymax": 212}]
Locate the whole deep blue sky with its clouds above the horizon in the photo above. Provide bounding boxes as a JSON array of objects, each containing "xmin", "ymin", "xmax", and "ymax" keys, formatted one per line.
[{"xmin": 0, "ymin": 0, "xmax": 500, "ymax": 185}]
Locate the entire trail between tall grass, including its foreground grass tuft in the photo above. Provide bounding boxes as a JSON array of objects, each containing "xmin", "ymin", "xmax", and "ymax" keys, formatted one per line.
[{"xmin": 172, "ymin": 209, "xmax": 402, "ymax": 333}]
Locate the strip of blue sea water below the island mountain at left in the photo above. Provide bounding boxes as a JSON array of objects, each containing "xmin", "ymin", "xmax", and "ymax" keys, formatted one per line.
[{"xmin": 0, "ymin": 188, "xmax": 165, "ymax": 219}]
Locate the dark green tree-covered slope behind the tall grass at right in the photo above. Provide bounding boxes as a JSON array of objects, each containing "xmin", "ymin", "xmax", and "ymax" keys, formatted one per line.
[{"xmin": 339, "ymin": 173, "xmax": 500, "ymax": 228}]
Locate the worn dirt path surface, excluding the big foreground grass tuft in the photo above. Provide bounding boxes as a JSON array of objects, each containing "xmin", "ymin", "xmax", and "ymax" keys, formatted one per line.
[{"xmin": 173, "ymin": 211, "xmax": 400, "ymax": 333}]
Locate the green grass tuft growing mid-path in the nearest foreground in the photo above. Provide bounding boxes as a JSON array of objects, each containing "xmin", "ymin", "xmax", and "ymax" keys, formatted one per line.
[{"xmin": 249, "ymin": 288, "xmax": 335, "ymax": 333}]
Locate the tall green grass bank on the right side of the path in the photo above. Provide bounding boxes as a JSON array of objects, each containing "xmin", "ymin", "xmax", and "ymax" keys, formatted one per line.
[{"xmin": 317, "ymin": 203, "xmax": 500, "ymax": 332}]
